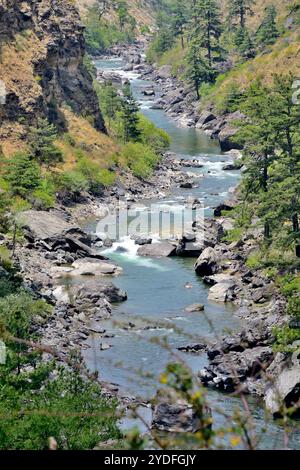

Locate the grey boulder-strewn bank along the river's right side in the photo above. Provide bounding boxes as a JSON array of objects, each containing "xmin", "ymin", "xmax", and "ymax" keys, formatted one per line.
[{"xmin": 107, "ymin": 42, "xmax": 300, "ymax": 415}]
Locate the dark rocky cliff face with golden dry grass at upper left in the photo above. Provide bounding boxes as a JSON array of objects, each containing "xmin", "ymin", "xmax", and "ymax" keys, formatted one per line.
[{"xmin": 0, "ymin": 0, "xmax": 105, "ymax": 145}]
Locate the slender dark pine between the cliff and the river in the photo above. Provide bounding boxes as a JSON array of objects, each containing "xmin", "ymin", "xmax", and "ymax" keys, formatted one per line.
[{"xmin": 121, "ymin": 84, "xmax": 140, "ymax": 142}]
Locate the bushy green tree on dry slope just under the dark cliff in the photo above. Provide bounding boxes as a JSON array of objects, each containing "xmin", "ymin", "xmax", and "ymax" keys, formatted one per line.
[{"xmin": 28, "ymin": 118, "xmax": 63, "ymax": 167}]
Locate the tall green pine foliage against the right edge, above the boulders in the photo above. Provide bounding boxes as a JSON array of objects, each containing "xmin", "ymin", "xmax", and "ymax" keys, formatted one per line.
[{"xmin": 237, "ymin": 75, "xmax": 300, "ymax": 258}]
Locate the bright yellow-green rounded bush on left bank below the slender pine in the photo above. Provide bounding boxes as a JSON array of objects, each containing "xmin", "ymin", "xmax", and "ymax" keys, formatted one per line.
[{"xmin": 122, "ymin": 142, "xmax": 159, "ymax": 178}]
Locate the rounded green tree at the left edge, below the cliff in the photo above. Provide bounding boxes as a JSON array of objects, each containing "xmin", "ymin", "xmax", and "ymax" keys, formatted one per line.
[{"xmin": 4, "ymin": 153, "xmax": 41, "ymax": 197}]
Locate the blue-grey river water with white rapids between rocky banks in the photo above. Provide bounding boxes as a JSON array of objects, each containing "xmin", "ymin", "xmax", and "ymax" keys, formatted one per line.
[{"xmin": 84, "ymin": 60, "xmax": 300, "ymax": 448}]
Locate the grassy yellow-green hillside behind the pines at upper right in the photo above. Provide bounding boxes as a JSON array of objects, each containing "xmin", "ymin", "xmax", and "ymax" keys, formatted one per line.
[{"xmin": 148, "ymin": 0, "xmax": 300, "ymax": 112}]
